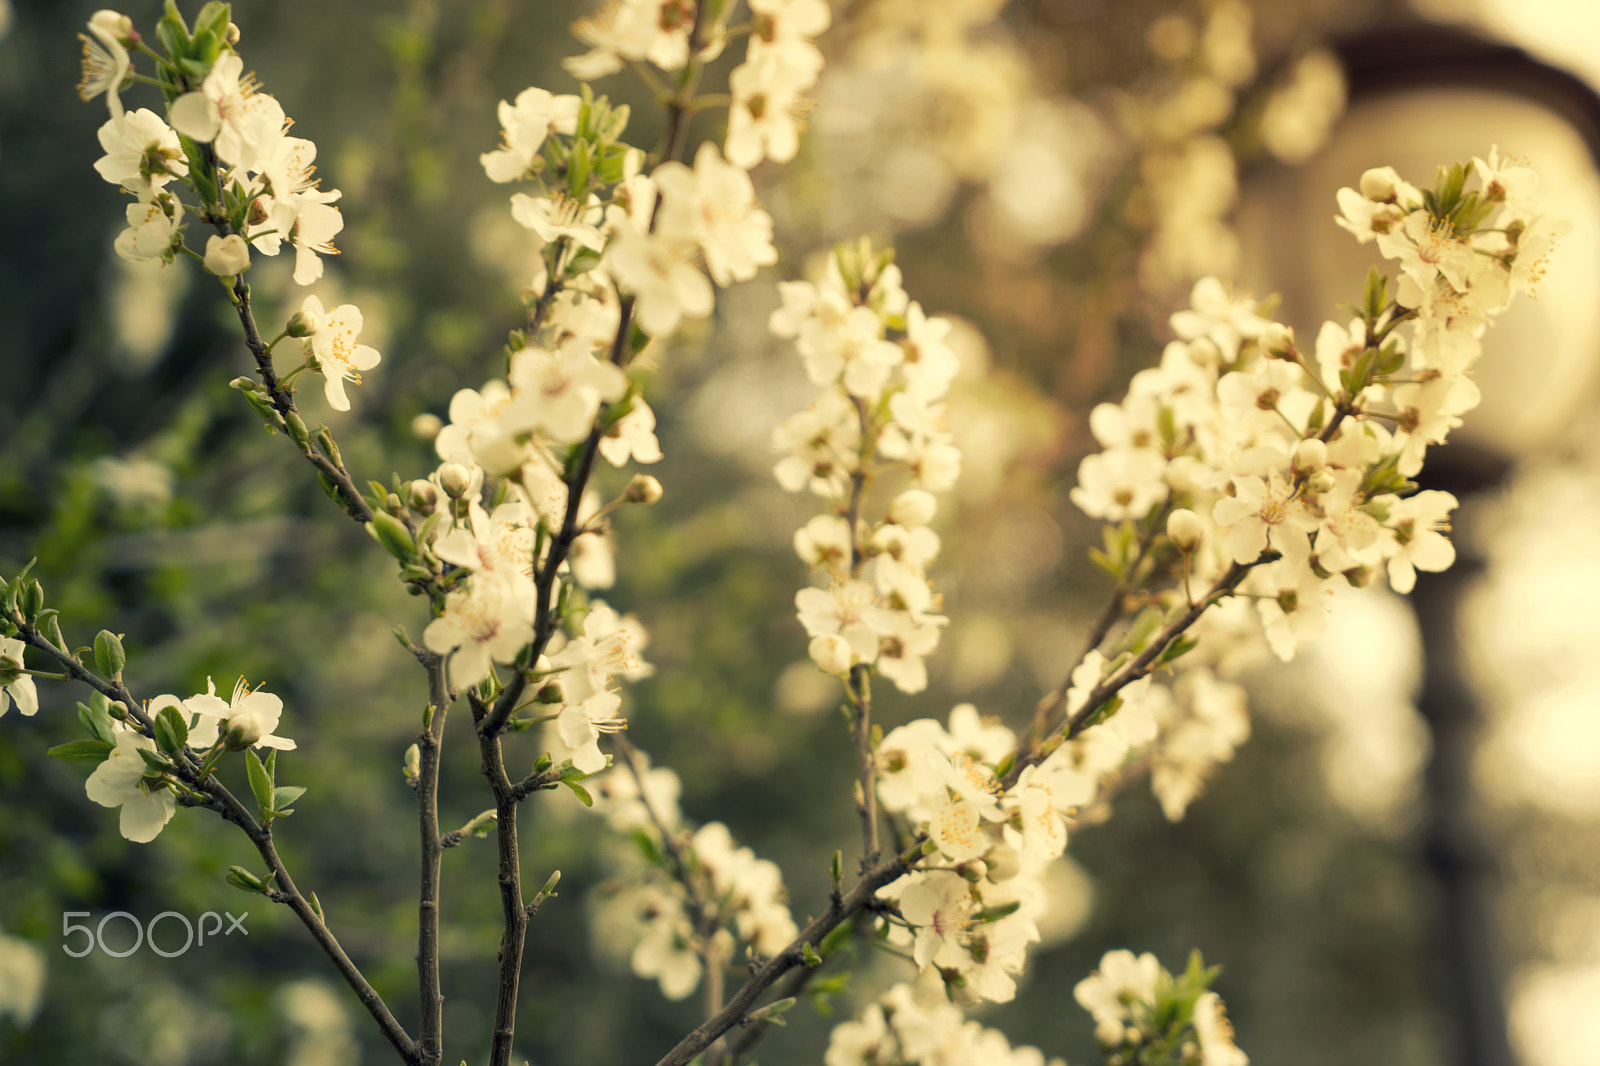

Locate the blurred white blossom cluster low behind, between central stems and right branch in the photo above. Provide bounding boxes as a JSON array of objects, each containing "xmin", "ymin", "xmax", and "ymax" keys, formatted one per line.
[{"xmin": 592, "ymin": 752, "xmax": 800, "ymax": 999}]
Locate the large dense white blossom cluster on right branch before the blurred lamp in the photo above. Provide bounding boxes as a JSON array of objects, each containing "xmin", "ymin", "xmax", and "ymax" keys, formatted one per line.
[{"xmin": 1067, "ymin": 152, "xmax": 1563, "ymax": 818}]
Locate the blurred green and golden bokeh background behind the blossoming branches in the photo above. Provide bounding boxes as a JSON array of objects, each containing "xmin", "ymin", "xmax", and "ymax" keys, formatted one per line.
[{"xmin": 0, "ymin": 0, "xmax": 1600, "ymax": 1066}]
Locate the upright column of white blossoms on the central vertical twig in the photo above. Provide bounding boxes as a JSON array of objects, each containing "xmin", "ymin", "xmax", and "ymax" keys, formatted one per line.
[{"xmin": 771, "ymin": 243, "xmax": 962, "ymax": 693}]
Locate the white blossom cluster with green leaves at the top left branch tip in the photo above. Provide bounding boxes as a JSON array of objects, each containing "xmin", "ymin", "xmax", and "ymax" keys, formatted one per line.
[{"xmin": 78, "ymin": 8, "xmax": 379, "ymax": 411}]
